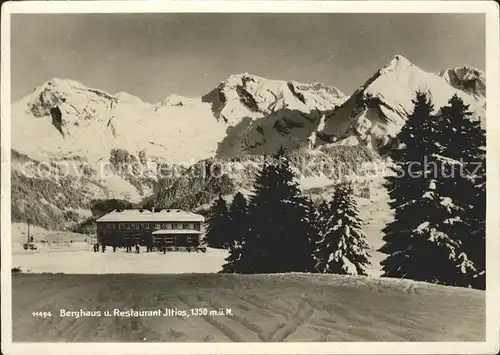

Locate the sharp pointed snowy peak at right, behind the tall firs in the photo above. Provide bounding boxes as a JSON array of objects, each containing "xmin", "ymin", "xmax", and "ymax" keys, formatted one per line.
[{"xmin": 316, "ymin": 55, "xmax": 485, "ymax": 147}]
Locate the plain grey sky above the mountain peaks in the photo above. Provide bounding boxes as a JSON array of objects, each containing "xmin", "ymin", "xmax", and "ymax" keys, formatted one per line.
[{"xmin": 11, "ymin": 13, "xmax": 485, "ymax": 103}]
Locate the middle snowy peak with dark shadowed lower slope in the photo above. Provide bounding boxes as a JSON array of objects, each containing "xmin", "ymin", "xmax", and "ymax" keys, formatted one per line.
[{"xmin": 203, "ymin": 73, "xmax": 346, "ymax": 157}]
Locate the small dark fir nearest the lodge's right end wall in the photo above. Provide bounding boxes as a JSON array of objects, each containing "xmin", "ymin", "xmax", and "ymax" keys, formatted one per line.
[{"xmin": 204, "ymin": 195, "xmax": 230, "ymax": 249}]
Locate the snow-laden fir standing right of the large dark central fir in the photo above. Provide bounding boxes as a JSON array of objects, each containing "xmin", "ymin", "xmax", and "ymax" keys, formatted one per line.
[{"xmin": 316, "ymin": 182, "xmax": 370, "ymax": 275}]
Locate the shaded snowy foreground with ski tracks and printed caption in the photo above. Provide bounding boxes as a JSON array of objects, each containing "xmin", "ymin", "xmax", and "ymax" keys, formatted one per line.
[{"xmin": 12, "ymin": 274, "xmax": 485, "ymax": 342}]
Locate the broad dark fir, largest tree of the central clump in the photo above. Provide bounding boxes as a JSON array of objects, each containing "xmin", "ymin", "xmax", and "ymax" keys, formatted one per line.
[{"xmin": 237, "ymin": 149, "xmax": 314, "ymax": 273}]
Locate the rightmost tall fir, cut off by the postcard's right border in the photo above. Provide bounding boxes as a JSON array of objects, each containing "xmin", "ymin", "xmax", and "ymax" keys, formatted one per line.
[{"xmin": 439, "ymin": 95, "xmax": 486, "ymax": 288}]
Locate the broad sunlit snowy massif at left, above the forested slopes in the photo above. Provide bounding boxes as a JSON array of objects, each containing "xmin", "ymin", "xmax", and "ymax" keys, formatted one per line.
[{"xmin": 12, "ymin": 80, "xmax": 225, "ymax": 162}]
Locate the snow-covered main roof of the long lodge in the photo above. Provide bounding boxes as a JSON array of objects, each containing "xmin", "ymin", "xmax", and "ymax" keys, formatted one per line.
[{"xmin": 97, "ymin": 209, "xmax": 205, "ymax": 223}]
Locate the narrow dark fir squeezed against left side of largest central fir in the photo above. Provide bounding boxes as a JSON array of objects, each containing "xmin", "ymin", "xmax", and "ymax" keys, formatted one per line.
[{"xmin": 222, "ymin": 192, "xmax": 248, "ymax": 273}]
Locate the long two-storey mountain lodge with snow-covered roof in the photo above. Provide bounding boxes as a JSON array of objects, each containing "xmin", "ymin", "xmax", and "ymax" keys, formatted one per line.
[{"xmin": 96, "ymin": 209, "xmax": 205, "ymax": 247}]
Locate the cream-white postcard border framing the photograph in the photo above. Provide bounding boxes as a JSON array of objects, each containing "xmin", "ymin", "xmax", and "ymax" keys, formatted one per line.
[{"xmin": 1, "ymin": 0, "xmax": 500, "ymax": 355}]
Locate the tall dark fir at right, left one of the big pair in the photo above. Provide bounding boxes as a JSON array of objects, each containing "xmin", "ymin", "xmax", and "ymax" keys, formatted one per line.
[{"xmin": 380, "ymin": 92, "xmax": 470, "ymax": 285}]
